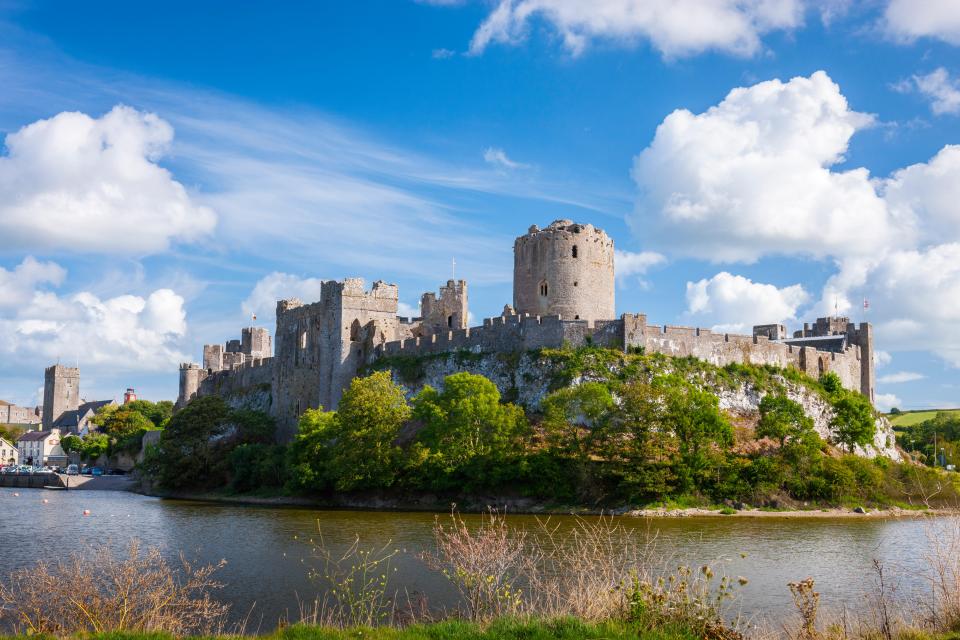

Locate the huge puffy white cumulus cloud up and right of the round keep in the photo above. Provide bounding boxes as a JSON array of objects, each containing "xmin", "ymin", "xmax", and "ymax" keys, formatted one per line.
[{"xmin": 631, "ymin": 71, "xmax": 911, "ymax": 261}]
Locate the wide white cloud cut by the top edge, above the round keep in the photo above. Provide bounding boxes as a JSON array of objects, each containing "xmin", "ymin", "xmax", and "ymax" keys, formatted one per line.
[{"xmin": 470, "ymin": 0, "xmax": 803, "ymax": 58}]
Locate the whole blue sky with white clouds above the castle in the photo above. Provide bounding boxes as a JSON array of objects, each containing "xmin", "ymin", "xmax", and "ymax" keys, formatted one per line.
[{"xmin": 0, "ymin": 0, "xmax": 960, "ymax": 408}]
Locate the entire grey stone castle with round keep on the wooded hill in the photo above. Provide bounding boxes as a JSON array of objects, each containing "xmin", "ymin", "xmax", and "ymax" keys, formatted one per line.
[{"xmin": 177, "ymin": 220, "xmax": 874, "ymax": 439}]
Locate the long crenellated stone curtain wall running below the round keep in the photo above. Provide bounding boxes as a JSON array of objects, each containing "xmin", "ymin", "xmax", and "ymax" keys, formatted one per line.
[{"xmin": 370, "ymin": 314, "xmax": 872, "ymax": 397}]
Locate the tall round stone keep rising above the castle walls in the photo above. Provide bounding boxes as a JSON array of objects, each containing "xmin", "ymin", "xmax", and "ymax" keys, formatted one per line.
[{"xmin": 513, "ymin": 220, "xmax": 616, "ymax": 324}]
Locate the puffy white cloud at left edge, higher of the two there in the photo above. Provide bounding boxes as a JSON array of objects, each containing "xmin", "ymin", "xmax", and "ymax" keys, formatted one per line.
[{"xmin": 0, "ymin": 106, "xmax": 216, "ymax": 255}]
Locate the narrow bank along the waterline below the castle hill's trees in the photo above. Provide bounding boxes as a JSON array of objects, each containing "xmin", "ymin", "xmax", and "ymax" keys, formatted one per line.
[{"xmin": 137, "ymin": 487, "xmax": 960, "ymax": 519}]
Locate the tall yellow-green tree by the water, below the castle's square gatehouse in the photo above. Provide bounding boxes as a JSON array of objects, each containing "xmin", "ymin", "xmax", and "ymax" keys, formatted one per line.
[{"xmin": 326, "ymin": 371, "xmax": 410, "ymax": 491}]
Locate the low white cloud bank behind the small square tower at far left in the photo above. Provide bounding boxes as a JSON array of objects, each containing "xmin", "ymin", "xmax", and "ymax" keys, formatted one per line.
[{"xmin": 0, "ymin": 272, "xmax": 187, "ymax": 372}]
